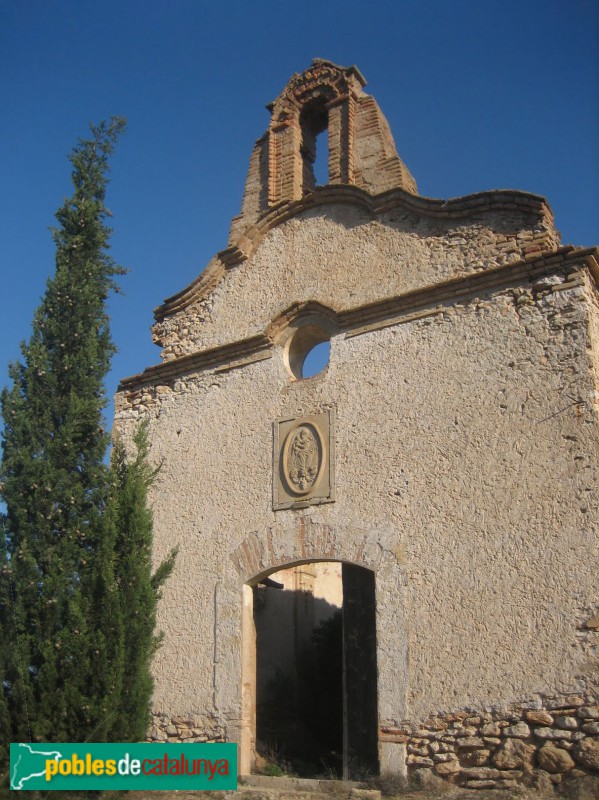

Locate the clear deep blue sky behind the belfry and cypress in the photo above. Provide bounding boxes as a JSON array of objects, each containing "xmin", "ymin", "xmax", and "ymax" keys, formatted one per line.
[{"xmin": 0, "ymin": 0, "xmax": 599, "ymax": 418}]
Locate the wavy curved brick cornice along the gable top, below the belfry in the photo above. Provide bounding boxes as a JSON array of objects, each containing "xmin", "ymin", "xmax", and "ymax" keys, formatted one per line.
[{"xmin": 154, "ymin": 185, "xmax": 553, "ymax": 321}]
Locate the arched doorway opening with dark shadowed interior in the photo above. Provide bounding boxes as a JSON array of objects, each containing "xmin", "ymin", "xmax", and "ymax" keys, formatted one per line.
[{"xmin": 241, "ymin": 561, "xmax": 378, "ymax": 779}]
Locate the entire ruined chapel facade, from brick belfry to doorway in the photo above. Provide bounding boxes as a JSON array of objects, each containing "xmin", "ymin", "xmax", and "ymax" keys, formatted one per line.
[{"xmin": 115, "ymin": 59, "xmax": 599, "ymax": 787}]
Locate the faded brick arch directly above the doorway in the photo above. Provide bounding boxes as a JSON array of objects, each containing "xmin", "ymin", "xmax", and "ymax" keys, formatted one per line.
[{"xmin": 229, "ymin": 517, "xmax": 398, "ymax": 584}]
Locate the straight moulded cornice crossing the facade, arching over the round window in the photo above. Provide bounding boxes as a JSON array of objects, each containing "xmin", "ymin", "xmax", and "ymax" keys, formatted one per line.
[{"xmin": 119, "ymin": 245, "xmax": 599, "ymax": 391}]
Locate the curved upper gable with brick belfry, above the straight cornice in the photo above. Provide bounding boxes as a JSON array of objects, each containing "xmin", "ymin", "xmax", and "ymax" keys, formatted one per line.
[{"xmin": 148, "ymin": 59, "xmax": 559, "ymax": 360}]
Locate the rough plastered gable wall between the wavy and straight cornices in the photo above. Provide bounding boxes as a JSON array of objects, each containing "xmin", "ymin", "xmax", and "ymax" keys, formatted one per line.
[{"xmin": 154, "ymin": 204, "xmax": 554, "ymax": 360}]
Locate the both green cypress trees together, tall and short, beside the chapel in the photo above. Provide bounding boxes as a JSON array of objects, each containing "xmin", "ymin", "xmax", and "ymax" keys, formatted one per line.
[{"xmin": 0, "ymin": 118, "xmax": 172, "ymax": 788}]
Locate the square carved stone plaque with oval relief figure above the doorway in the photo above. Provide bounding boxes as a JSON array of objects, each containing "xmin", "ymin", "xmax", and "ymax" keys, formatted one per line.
[{"xmin": 273, "ymin": 410, "xmax": 335, "ymax": 511}]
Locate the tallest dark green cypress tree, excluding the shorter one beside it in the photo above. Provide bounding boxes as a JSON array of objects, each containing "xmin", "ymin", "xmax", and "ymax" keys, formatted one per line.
[{"xmin": 0, "ymin": 119, "xmax": 124, "ymax": 752}]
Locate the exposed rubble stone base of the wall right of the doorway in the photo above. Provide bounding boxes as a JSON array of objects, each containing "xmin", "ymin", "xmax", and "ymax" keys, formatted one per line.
[{"xmin": 381, "ymin": 693, "xmax": 599, "ymax": 789}]
